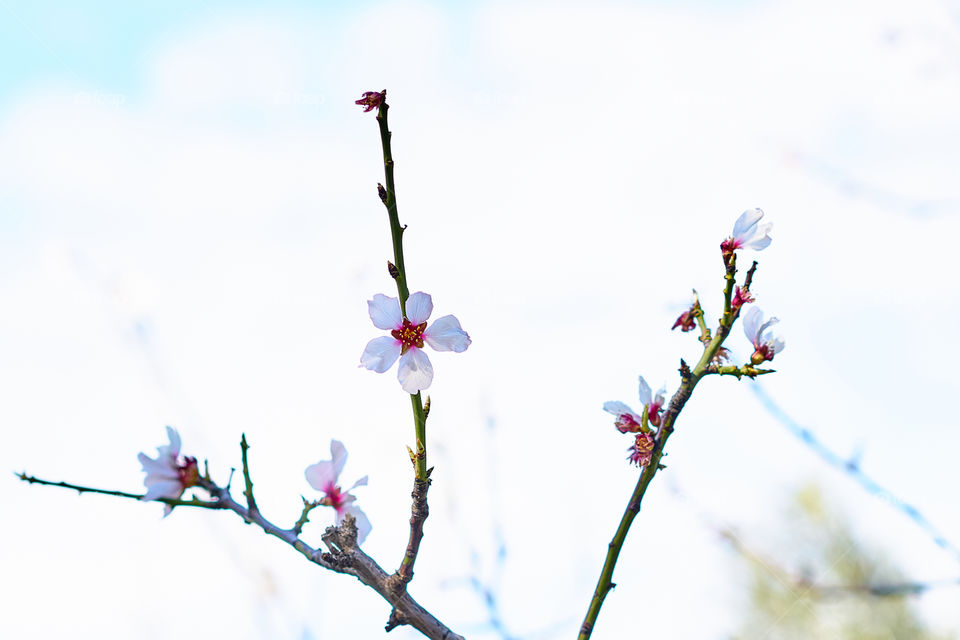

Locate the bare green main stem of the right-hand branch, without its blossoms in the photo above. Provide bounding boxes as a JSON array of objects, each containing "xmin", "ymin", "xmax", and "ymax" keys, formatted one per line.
[{"xmin": 577, "ymin": 259, "xmax": 752, "ymax": 640}]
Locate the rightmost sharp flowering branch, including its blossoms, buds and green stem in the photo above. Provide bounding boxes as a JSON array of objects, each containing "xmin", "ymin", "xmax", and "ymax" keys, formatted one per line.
[{"xmin": 578, "ymin": 209, "xmax": 783, "ymax": 640}]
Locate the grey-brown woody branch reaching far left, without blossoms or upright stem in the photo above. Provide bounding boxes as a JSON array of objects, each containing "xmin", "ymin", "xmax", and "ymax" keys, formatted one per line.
[{"xmin": 17, "ymin": 436, "xmax": 463, "ymax": 640}]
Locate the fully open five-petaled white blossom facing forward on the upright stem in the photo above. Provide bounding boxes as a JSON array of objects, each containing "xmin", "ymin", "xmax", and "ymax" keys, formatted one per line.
[{"xmin": 360, "ymin": 291, "xmax": 470, "ymax": 395}]
